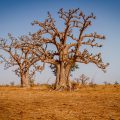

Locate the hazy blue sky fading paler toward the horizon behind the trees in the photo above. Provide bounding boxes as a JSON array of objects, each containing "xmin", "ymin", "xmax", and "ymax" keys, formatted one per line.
[{"xmin": 0, "ymin": 0, "xmax": 120, "ymax": 84}]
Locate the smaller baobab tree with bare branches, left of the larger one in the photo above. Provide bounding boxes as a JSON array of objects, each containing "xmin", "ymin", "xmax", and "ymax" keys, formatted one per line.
[{"xmin": 0, "ymin": 34, "xmax": 43, "ymax": 87}]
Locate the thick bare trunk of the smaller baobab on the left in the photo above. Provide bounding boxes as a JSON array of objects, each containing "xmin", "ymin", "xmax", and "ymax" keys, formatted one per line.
[{"xmin": 21, "ymin": 71, "xmax": 30, "ymax": 87}]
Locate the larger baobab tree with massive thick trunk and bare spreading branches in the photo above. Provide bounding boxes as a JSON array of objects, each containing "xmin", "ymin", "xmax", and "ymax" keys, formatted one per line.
[{"xmin": 27, "ymin": 8, "xmax": 109, "ymax": 89}]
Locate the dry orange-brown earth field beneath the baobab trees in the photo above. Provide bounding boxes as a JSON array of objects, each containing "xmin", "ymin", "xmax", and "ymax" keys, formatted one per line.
[{"xmin": 0, "ymin": 85, "xmax": 120, "ymax": 120}]
